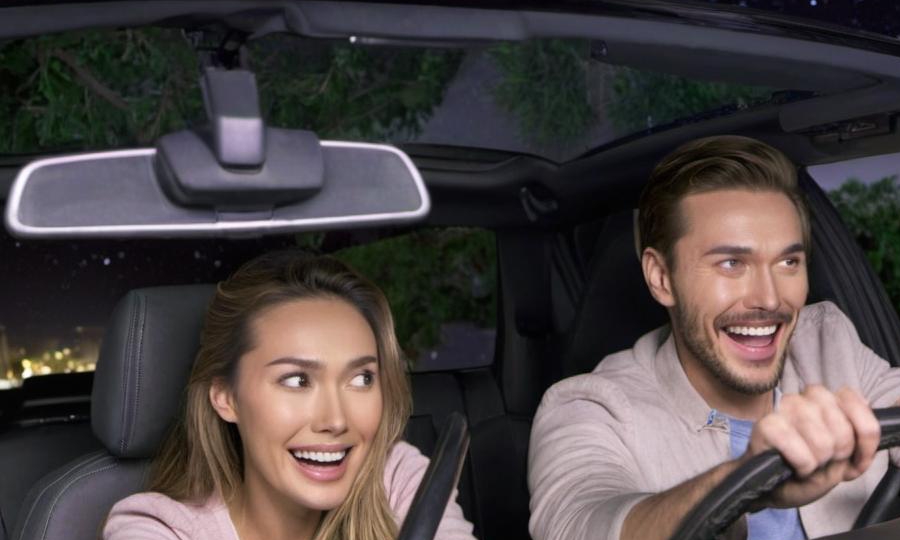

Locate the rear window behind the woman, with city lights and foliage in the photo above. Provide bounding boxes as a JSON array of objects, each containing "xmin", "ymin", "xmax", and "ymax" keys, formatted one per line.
[{"xmin": 0, "ymin": 228, "xmax": 497, "ymax": 391}]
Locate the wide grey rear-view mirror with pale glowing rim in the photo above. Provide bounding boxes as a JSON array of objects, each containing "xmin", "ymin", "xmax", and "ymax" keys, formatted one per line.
[{"xmin": 6, "ymin": 141, "xmax": 430, "ymax": 238}]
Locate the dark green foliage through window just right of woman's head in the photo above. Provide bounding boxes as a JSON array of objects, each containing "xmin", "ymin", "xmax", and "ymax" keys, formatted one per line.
[{"xmin": 335, "ymin": 228, "xmax": 497, "ymax": 358}]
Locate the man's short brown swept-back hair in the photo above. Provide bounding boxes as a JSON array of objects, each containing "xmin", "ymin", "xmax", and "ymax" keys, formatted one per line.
[{"xmin": 638, "ymin": 135, "xmax": 810, "ymax": 265}]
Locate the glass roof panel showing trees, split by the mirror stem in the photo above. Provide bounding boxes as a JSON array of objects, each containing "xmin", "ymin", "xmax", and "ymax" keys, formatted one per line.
[{"xmin": 0, "ymin": 28, "xmax": 795, "ymax": 161}]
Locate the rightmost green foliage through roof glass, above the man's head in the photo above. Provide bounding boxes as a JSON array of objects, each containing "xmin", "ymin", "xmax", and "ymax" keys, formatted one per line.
[{"xmin": 606, "ymin": 67, "xmax": 772, "ymax": 134}]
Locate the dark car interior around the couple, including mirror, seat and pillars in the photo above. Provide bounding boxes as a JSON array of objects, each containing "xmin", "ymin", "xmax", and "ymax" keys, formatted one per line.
[{"xmin": 0, "ymin": 0, "xmax": 900, "ymax": 540}]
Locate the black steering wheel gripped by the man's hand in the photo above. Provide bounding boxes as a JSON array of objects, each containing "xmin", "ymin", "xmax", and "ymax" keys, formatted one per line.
[{"xmin": 671, "ymin": 407, "xmax": 900, "ymax": 540}]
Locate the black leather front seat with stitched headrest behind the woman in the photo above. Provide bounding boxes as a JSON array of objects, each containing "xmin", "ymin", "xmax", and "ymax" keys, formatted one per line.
[{"xmin": 12, "ymin": 285, "xmax": 213, "ymax": 540}]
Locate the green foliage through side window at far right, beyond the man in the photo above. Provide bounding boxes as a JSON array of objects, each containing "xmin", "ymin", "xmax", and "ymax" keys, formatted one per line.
[{"xmin": 829, "ymin": 176, "xmax": 900, "ymax": 311}]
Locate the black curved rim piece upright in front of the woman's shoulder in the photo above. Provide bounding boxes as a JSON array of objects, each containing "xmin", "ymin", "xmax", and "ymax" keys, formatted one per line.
[{"xmin": 397, "ymin": 412, "xmax": 469, "ymax": 540}]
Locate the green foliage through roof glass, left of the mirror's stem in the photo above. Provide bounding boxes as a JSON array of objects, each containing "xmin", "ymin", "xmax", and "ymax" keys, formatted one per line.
[{"xmin": 0, "ymin": 28, "xmax": 202, "ymax": 153}]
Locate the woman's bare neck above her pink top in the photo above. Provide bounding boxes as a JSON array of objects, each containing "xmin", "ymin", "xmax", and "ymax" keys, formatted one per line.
[{"xmin": 228, "ymin": 482, "xmax": 322, "ymax": 540}]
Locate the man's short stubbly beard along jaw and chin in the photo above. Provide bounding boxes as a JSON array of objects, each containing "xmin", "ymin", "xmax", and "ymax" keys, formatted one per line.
[{"xmin": 673, "ymin": 300, "xmax": 789, "ymax": 396}]
